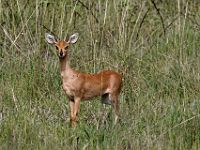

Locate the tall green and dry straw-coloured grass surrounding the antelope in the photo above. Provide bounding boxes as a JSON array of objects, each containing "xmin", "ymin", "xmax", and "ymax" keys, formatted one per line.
[{"xmin": 0, "ymin": 0, "xmax": 200, "ymax": 150}]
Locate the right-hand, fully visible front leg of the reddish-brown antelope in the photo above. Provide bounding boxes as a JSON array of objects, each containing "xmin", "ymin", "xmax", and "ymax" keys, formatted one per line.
[{"xmin": 70, "ymin": 98, "xmax": 81, "ymax": 127}]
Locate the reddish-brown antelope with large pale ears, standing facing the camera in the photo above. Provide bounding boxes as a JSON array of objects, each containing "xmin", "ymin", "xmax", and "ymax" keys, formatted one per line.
[{"xmin": 45, "ymin": 33, "xmax": 122, "ymax": 127}]
